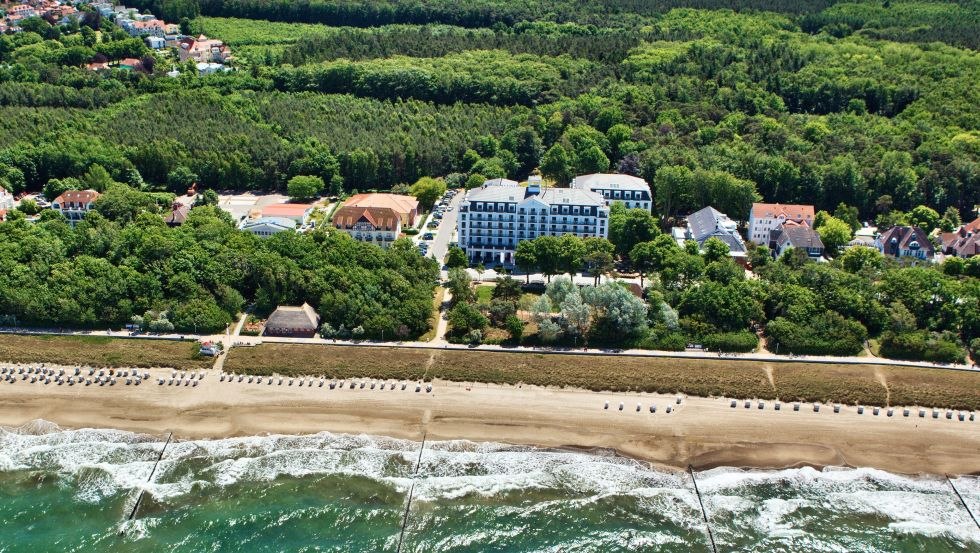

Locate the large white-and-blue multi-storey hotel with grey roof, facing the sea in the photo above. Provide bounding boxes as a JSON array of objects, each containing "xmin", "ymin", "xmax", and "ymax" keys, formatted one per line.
[{"xmin": 458, "ymin": 176, "xmax": 609, "ymax": 265}]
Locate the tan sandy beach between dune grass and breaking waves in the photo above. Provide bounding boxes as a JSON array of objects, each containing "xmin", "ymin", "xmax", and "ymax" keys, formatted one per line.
[{"xmin": 0, "ymin": 362, "xmax": 980, "ymax": 474}]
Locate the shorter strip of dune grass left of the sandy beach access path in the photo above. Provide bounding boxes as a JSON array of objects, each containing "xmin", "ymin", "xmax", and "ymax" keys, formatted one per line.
[{"xmin": 0, "ymin": 334, "xmax": 214, "ymax": 370}]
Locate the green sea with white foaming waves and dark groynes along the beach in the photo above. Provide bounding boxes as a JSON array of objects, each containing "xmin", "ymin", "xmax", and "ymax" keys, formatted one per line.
[{"xmin": 0, "ymin": 415, "xmax": 980, "ymax": 553}]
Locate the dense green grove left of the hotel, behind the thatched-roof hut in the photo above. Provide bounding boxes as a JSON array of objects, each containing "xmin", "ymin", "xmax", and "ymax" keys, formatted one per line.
[{"xmin": 0, "ymin": 204, "xmax": 438, "ymax": 338}]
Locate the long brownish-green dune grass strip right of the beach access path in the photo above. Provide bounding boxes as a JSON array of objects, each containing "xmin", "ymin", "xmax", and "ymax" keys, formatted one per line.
[{"xmin": 225, "ymin": 344, "xmax": 980, "ymax": 409}]
